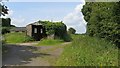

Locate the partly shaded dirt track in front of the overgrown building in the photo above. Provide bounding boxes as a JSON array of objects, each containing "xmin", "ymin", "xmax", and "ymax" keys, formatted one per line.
[{"xmin": 2, "ymin": 42, "xmax": 70, "ymax": 66}]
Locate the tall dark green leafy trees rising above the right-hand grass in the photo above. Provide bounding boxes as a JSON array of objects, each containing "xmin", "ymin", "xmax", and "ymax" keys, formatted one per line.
[{"xmin": 82, "ymin": 2, "xmax": 120, "ymax": 47}]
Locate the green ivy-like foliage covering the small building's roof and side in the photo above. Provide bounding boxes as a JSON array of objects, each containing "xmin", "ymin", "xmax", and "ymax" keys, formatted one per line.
[{"xmin": 38, "ymin": 21, "xmax": 70, "ymax": 41}]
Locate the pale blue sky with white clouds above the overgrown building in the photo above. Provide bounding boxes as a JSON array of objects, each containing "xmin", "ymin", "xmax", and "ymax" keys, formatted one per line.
[{"xmin": 1, "ymin": 0, "xmax": 87, "ymax": 33}]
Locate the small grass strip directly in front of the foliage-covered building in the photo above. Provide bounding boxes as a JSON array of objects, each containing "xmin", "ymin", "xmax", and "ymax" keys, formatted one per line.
[{"xmin": 37, "ymin": 39, "xmax": 63, "ymax": 46}]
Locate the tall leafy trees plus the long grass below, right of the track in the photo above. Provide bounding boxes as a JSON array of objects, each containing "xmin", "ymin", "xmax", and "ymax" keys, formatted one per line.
[{"xmin": 56, "ymin": 2, "xmax": 120, "ymax": 66}]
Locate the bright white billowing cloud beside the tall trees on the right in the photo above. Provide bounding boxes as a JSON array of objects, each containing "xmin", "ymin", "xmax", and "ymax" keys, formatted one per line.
[{"xmin": 63, "ymin": 3, "xmax": 87, "ymax": 33}]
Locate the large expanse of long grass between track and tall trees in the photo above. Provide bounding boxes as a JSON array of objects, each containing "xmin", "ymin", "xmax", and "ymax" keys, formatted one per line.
[{"xmin": 55, "ymin": 35, "xmax": 118, "ymax": 66}]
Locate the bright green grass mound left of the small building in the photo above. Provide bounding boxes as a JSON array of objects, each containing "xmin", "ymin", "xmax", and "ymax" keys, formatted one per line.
[{"xmin": 4, "ymin": 32, "xmax": 34, "ymax": 43}]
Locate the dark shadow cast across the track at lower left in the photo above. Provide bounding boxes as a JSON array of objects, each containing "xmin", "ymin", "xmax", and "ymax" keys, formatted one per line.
[{"xmin": 2, "ymin": 44, "xmax": 50, "ymax": 66}]
